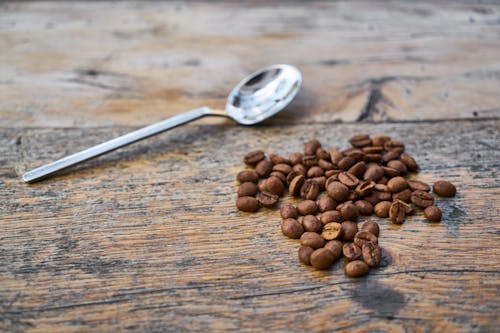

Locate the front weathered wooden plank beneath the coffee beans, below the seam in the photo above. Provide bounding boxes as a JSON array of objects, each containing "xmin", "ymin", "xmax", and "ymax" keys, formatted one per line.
[{"xmin": 0, "ymin": 120, "xmax": 500, "ymax": 332}]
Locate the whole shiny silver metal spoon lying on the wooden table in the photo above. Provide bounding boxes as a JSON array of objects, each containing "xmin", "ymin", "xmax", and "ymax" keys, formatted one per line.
[{"xmin": 23, "ymin": 65, "xmax": 302, "ymax": 183}]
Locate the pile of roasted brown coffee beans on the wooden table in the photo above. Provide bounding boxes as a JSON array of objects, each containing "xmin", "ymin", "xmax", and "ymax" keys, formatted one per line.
[{"xmin": 236, "ymin": 134, "xmax": 456, "ymax": 277}]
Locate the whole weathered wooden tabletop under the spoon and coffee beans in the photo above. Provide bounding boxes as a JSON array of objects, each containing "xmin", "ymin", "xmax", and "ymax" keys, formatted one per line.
[{"xmin": 0, "ymin": 1, "xmax": 500, "ymax": 332}]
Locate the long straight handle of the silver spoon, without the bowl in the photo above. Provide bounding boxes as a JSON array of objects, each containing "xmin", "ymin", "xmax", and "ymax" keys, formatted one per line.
[{"xmin": 23, "ymin": 107, "xmax": 213, "ymax": 183}]
